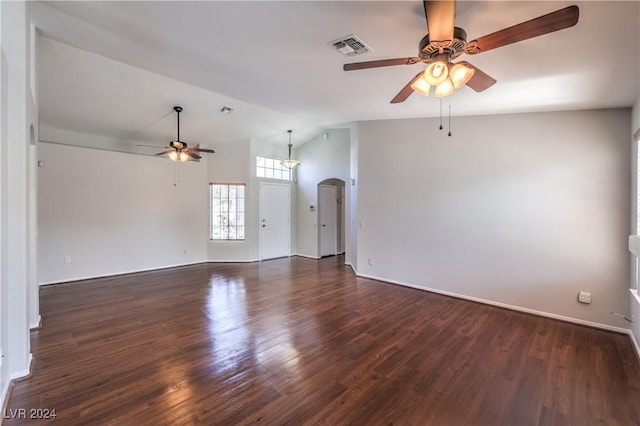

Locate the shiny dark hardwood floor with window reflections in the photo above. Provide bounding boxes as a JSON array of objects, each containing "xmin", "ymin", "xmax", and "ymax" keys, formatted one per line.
[{"xmin": 3, "ymin": 257, "xmax": 640, "ymax": 426}]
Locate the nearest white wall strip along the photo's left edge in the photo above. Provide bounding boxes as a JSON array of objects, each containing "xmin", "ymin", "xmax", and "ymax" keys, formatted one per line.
[{"xmin": 0, "ymin": 2, "xmax": 37, "ymax": 410}]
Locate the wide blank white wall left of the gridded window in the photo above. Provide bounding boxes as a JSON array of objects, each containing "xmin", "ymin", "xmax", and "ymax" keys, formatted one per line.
[{"xmin": 38, "ymin": 141, "xmax": 208, "ymax": 283}]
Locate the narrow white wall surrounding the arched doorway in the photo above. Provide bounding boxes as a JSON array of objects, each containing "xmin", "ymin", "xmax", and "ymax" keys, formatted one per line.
[{"xmin": 295, "ymin": 129, "xmax": 351, "ymax": 258}]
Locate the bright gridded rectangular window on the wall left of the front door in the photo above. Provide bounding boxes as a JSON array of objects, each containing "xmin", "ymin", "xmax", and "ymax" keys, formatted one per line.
[{"xmin": 209, "ymin": 183, "xmax": 245, "ymax": 240}]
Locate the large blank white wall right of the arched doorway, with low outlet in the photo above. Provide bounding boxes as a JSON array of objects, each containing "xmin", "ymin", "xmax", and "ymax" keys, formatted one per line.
[{"xmin": 357, "ymin": 109, "xmax": 631, "ymax": 328}]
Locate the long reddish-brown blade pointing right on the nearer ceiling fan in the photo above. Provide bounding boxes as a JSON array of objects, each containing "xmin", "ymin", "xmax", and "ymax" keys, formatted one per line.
[{"xmin": 464, "ymin": 5, "xmax": 580, "ymax": 55}]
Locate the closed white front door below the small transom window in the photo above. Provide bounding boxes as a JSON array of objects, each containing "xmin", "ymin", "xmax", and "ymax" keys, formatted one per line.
[{"xmin": 260, "ymin": 182, "xmax": 291, "ymax": 259}]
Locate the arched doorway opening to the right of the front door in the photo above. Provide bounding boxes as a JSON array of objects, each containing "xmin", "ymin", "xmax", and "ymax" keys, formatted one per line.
[{"xmin": 317, "ymin": 179, "xmax": 345, "ymax": 257}]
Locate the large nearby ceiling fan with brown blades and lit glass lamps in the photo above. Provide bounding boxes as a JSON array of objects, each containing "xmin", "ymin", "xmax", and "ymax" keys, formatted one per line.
[{"xmin": 343, "ymin": 0, "xmax": 580, "ymax": 104}]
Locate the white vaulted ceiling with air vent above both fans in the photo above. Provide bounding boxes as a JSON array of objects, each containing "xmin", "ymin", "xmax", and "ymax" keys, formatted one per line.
[{"xmin": 32, "ymin": 1, "xmax": 640, "ymax": 152}]
